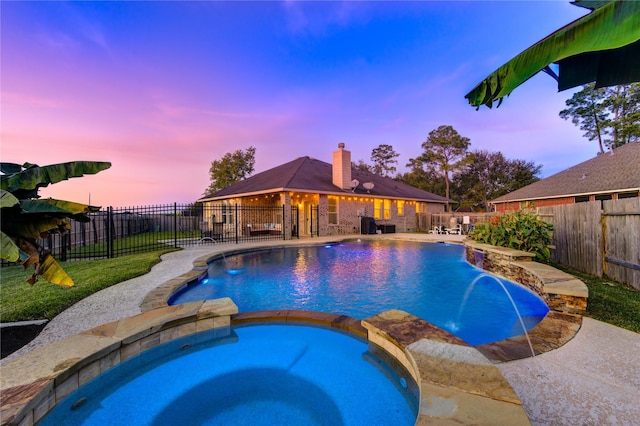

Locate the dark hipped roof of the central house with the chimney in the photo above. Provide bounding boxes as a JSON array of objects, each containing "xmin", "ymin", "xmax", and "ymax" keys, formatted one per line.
[{"xmin": 198, "ymin": 157, "xmax": 453, "ymax": 203}]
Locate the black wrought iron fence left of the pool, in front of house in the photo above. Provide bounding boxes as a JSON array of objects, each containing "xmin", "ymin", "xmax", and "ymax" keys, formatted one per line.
[{"xmin": 39, "ymin": 203, "xmax": 304, "ymax": 261}]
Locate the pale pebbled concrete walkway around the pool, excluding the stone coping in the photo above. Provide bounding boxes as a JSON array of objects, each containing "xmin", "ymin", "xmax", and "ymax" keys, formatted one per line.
[{"xmin": 0, "ymin": 234, "xmax": 640, "ymax": 426}]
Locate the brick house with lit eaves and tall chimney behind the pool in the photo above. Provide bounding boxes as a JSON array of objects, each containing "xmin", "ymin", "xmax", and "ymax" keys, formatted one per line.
[{"xmin": 197, "ymin": 143, "xmax": 453, "ymax": 238}]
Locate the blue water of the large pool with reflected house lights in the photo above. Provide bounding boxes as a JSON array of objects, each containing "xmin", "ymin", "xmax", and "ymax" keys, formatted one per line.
[{"xmin": 168, "ymin": 241, "xmax": 549, "ymax": 345}]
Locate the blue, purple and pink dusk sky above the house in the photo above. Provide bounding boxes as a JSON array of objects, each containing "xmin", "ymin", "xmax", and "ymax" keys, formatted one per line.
[{"xmin": 0, "ymin": 0, "xmax": 597, "ymax": 207}]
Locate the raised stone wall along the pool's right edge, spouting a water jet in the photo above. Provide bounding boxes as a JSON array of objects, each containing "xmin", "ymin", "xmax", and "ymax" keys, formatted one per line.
[{"xmin": 464, "ymin": 240, "xmax": 589, "ymax": 315}]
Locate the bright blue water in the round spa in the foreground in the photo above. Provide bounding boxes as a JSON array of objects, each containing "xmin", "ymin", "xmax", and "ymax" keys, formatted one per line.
[{"xmin": 39, "ymin": 325, "xmax": 418, "ymax": 426}]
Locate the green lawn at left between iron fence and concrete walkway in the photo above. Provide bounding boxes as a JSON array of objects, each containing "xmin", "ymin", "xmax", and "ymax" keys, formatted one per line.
[{"xmin": 0, "ymin": 248, "xmax": 175, "ymax": 322}]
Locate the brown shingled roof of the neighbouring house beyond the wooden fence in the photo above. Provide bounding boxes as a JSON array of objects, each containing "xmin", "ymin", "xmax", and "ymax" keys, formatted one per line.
[{"xmin": 491, "ymin": 142, "xmax": 640, "ymax": 204}]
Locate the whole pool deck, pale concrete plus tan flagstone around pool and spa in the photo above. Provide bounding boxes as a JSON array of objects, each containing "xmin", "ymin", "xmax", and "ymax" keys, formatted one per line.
[{"xmin": 0, "ymin": 234, "xmax": 640, "ymax": 425}]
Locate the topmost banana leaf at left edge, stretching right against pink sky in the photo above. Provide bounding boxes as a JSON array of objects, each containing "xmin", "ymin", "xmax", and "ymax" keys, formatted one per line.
[{"xmin": 0, "ymin": 161, "xmax": 111, "ymax": 199}]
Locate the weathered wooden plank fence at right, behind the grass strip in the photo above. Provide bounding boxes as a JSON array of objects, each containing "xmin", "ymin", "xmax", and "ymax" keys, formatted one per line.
[{"xmin": 538, "ymin": 198, "xmax": 640, "ymax": 290}]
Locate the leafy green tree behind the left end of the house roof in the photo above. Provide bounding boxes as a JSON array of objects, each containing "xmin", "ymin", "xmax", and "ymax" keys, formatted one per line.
[{"xmin": 203, "ymin": 146, "xmax": 256, "ymax": 196}]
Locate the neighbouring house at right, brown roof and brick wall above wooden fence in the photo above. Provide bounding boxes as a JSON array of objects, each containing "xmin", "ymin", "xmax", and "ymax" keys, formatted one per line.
[{"xmin": 491, "ymin": 142, "xmax": 640, "ymax": 213}]
